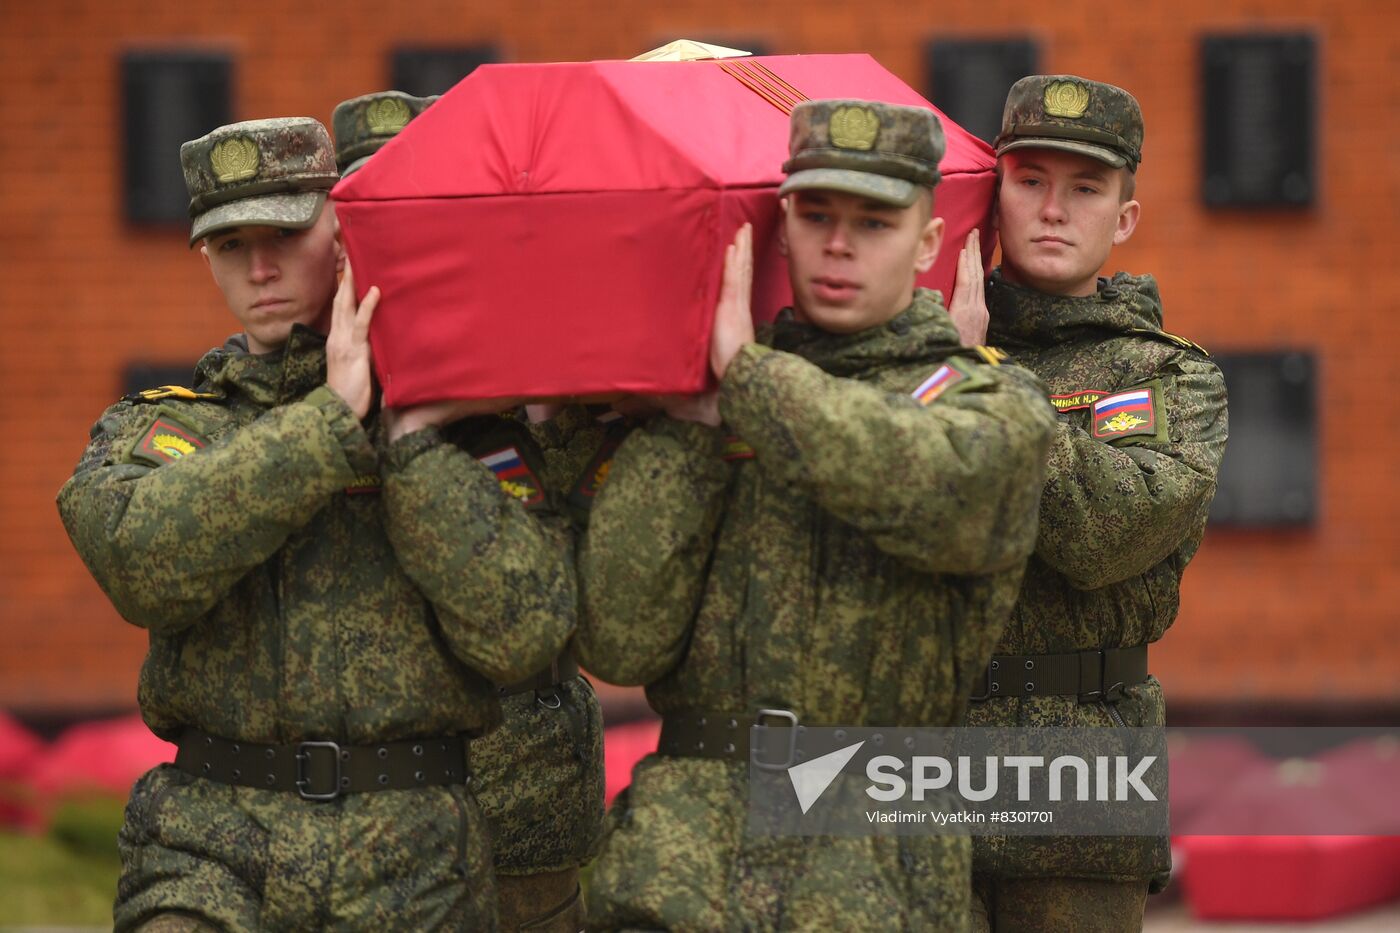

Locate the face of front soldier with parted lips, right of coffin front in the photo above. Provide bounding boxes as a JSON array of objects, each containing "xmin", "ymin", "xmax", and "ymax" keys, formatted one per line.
[{"xmin": 778, "ymin": 191, "xmax": 944, "ymax": 333}]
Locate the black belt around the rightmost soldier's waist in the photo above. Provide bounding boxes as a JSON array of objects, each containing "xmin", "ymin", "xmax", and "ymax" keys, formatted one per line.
[{"xmin": 972, "ymin": 644, "xmax": 1147, "ymax": 703}]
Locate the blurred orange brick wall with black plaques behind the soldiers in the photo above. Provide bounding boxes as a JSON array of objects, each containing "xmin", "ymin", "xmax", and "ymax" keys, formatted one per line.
[{"xmin": 0, "ymin": 0, "xmax": 1400, "ymax": 721}]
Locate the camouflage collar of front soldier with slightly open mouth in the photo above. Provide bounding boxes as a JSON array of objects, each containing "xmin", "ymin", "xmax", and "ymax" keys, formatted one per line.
[{"xmin": 759, "ymin": 289, "xmax": 958, "ymax": 377}]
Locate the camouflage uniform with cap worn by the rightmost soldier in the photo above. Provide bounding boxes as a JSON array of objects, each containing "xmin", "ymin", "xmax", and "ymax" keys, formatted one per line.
[{"xmin": 967, "ymin": 76, "xmax": 1226, "ymax": 930}]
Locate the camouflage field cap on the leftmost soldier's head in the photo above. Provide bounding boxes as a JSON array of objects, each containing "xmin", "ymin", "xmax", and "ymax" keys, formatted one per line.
[{"xmin": 179, "ymin": 116, "xmax": 340, "ymax": 245}]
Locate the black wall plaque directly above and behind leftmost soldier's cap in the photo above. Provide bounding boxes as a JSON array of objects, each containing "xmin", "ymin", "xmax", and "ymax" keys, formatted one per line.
[{"xmin": 120, "ymin": 50, "xmax": 232, "ymax": 224}]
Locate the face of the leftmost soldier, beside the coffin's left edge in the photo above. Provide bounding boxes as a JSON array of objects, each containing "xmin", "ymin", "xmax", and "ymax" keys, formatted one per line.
[{"xmin": 200, "ymin": 205, "xmax": 343, "ymax": 353}]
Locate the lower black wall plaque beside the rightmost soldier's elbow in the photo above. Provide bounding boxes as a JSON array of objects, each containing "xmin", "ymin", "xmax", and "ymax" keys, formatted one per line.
[{"xmin": 1211, "ymin": 350, "xmax": 1317, "ymax": 527}]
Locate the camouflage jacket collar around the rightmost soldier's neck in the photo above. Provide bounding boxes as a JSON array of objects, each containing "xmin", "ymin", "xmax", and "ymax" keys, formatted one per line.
[{"xmin": 987, "ymin": 268, "xmax": 1162, "ymax": 349}]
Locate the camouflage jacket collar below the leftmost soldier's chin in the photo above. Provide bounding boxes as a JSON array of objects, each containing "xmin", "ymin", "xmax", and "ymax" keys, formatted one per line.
[{"xmin": 195, "ymin": 324, "xmax": 326, "ymax": 408}]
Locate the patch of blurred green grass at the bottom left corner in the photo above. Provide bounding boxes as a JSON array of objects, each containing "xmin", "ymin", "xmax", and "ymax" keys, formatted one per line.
[{"xmin": 0, "ymin": 800, "xmax": 122, "ymax": 929}]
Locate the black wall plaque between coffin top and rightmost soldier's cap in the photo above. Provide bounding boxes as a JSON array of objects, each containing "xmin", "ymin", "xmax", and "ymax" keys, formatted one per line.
[{"xmin": 924, "ymin": 39, "xmax": 1040, "ymax": 143}]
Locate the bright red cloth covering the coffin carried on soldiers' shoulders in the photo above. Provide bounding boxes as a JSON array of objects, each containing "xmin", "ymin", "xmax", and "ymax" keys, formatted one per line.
[{"xmin": 332, "ymin": 55, "xmax": 994, "ymax": 406}]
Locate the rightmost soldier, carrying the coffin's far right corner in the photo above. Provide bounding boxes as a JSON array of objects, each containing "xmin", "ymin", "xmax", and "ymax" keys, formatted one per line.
[{"xmin": 952, "ymin": 74, "xmax": 1226, "ymax": 930}]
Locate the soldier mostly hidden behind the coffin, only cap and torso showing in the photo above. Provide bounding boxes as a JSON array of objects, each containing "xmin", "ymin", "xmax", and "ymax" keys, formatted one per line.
[{"xmin": 332, "ymin": 91, "xmax": 603, "ymax": 932}]
